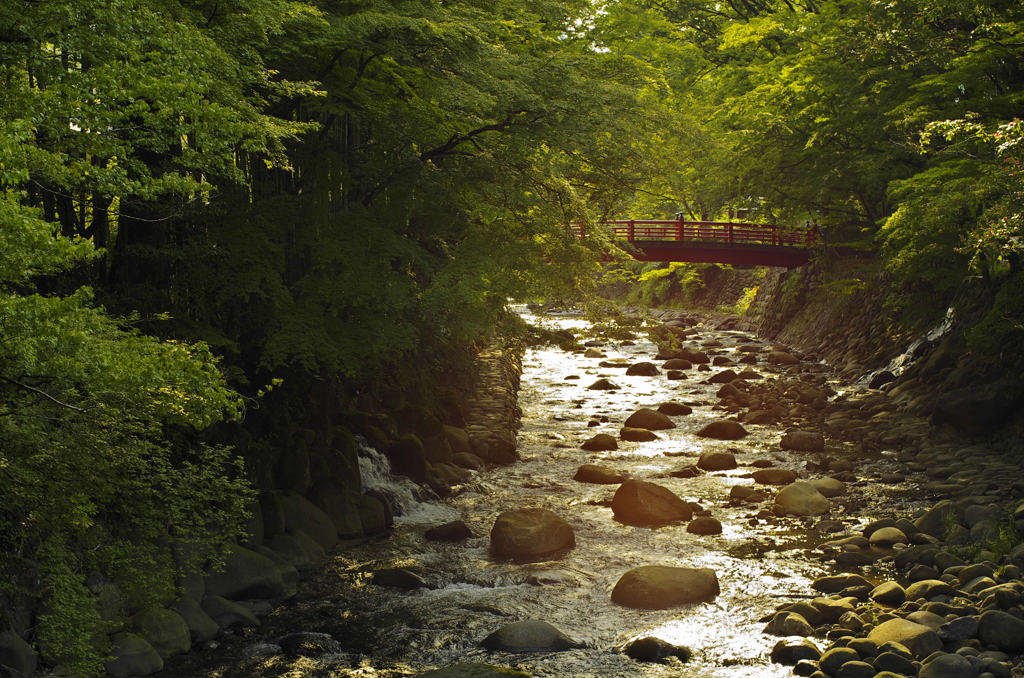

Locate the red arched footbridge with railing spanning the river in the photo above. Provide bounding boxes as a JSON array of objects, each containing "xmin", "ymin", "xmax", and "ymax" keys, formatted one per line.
[{"xmin": 572, "ymin": 219, "xmax": 815, "ymax": 268}]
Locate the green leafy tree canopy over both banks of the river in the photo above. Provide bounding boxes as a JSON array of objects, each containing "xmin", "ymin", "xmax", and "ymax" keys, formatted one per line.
[{"xmin": 0, "ymin": 0, "xmax": 1024, "ymax": 666}]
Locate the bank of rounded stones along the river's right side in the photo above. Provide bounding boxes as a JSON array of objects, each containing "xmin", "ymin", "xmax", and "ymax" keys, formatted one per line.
[{"xmin": 638, "ymin": 311, "xmax": 1024, "ymax": 678}]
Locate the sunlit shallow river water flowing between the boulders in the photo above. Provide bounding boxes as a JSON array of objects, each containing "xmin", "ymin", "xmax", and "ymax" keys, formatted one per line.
[{"xmin": 201, "ymin": 316, "xmax": 905, "ymax": 678}]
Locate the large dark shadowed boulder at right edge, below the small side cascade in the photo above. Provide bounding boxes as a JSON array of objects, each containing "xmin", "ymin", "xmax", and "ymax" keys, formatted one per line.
[{"xmin": 931, "ymin": 379, "xmax": 1024, "ymax": 435}]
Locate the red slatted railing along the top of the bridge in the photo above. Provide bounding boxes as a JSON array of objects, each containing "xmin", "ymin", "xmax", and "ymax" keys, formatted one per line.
[{"xmin": 571, "ymin": 219, "xmax": 814, "ymax": 248}]
